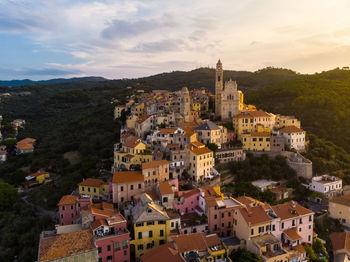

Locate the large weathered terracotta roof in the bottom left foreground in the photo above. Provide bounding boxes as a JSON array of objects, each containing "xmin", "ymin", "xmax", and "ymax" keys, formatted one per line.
[{"xmin": 38, "ymin": 229, "xmax": 95, "ymax": 261}]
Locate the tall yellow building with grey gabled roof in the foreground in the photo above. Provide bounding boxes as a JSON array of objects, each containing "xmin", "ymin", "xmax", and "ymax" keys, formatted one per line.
[{"xmin": 130, "ymin": 194, "xmax": 170, "ymax": 258}]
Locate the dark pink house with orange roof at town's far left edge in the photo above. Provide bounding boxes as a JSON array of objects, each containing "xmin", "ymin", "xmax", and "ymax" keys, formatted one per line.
[{"xmin": 57, "ymin": 195, "xmax": 91, "ymax": 225}]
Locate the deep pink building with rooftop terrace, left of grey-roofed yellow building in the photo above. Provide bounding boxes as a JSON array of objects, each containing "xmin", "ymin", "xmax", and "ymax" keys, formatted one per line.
[{"xmin": 91, "ymin": 205, "xmax": 130, "ymax": 262}]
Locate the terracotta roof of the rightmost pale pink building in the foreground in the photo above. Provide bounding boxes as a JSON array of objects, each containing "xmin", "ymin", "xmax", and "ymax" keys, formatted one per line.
[{"xmin": 271, "ymin": 201, "xmax": 313, "ymax": 220}]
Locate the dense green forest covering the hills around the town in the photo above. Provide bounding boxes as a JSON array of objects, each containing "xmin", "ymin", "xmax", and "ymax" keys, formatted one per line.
[{"xmin": 0, "ymin": 68, "xmax": 350, "ymax": 261}]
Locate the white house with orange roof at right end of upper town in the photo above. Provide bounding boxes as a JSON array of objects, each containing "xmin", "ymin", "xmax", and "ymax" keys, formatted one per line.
[{"xmin": 280, "ymin": 126, "xmax": 306, "ymax": 151}]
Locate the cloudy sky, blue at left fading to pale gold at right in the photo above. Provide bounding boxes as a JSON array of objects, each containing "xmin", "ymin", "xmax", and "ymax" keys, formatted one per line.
[{"xmin": 0, "ymin": 0, "xmax": 350, "ymax": 80}]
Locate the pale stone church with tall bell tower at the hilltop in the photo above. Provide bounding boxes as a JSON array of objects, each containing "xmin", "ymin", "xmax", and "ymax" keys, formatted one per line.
[{"xmin": 215, "ymin": 59, "xmax": 243, "ymax": 121}]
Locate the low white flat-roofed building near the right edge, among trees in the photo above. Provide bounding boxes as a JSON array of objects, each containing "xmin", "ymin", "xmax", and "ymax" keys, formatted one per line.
[{"xmin": 309, "ymin": 175, "xmax": 343, "ymax": 198}]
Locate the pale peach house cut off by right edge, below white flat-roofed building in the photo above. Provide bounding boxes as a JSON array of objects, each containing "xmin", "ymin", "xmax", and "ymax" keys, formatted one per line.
[{"xmin": 328, "ymin": 194, "xmax": 350, "ymax": 227}]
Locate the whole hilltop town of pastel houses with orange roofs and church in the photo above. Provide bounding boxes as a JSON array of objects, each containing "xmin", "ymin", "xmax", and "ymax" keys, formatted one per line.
[{"xmin": 8, "ymin": 60, "xmax": 350, "ymax": 262}]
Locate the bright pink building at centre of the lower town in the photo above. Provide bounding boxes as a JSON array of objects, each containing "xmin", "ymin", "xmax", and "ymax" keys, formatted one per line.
[{"xmin": 174, "ymin": 188, "xmax": 200, "ymax": 215}]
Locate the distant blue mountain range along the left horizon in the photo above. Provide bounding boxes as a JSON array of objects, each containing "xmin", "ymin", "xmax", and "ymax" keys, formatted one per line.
[{"xmin": 0, "ymin": 76, "xmax": 107, "ymax": 87}]
